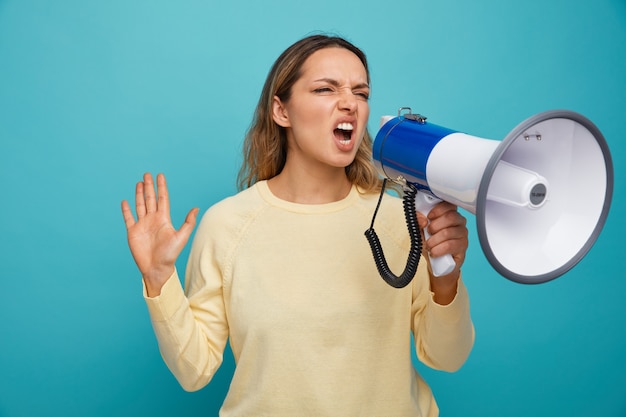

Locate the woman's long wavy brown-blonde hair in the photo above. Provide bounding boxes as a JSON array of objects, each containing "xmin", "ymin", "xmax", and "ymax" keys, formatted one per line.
[{"xmin": 237, "ymin": 34, "xmax": 381, "ymax": 192}]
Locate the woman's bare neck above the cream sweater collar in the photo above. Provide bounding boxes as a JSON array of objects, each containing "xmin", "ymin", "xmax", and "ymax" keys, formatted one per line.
[{"xmin": 268, "ymin": 166, "xmax": 352, "ymax": 204}]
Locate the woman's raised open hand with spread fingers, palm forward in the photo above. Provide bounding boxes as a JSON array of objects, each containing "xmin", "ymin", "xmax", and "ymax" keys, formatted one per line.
[{"xmin": 122, "ymin": 173, "xmax": 198, "ymax": 297}]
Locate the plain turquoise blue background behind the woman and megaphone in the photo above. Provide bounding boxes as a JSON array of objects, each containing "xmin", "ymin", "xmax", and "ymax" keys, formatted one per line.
[{"xmin": 0, "ymin": 0, "xmax": 626, "ymax": 417}]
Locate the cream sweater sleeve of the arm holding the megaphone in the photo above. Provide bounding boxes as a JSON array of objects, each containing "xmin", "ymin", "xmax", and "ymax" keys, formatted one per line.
[{"xmin": 413, "ymin": 272, "xmax": 474, "ymax": 372}]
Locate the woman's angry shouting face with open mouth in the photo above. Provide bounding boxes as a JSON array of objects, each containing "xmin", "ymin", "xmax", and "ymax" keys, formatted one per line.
[{"xmin": 272, "ymin": 47, "xmax": 370, "ymax": 174}]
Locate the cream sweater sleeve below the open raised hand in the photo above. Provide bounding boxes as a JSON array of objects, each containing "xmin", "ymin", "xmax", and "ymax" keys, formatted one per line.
[{"xmin": 144, "ymin": 211, "xmax": 228, "ymax": 391}]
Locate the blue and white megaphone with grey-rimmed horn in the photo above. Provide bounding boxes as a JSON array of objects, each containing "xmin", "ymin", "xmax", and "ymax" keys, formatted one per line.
[{"xmin": 373, "ymin": 107, "xmax": 613, "ymax": 284}]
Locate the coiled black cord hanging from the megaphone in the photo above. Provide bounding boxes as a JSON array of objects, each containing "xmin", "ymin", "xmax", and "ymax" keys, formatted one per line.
[{"xmin": 365, "ymin": 179, "xmax": 422, "ymax": 288}]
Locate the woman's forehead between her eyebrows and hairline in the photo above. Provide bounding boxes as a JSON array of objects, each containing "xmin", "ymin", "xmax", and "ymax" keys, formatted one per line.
[{"xmin": 301, "ymin": 47, "xmax": 368, "ymax": 83}]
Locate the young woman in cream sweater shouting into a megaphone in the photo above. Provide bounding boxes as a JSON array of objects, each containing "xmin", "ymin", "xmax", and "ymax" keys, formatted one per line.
[{"xmin": 122, "ymin": 35, "xmax": 474, "ymax": 417}]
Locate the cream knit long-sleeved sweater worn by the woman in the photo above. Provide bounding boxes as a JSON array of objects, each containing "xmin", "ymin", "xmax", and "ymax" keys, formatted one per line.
[{"xmin": 146, "ymin": 182, "xmax": 474, "ymax": 417}]
